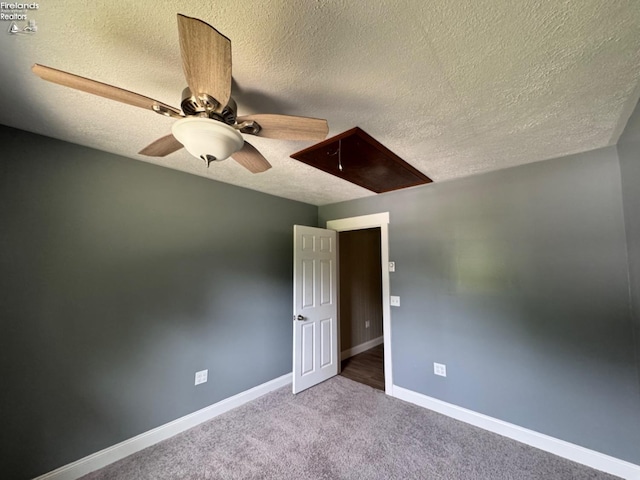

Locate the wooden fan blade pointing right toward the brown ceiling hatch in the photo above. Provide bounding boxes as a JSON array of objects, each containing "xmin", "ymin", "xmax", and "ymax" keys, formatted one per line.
[{"xmin": 237, "ymin": 113, "xmax": 329, "ymax": 141}]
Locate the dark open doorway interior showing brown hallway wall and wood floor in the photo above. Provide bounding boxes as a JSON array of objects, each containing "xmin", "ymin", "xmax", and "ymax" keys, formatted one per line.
[{"xmin": 338, "ymin": 227, "xmax": 385, "ymax": 391}]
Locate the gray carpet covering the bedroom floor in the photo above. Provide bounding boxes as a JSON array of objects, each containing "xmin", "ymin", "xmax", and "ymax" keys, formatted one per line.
[{"xmin": 82, "ymin": 377, "xmax": 617, "ymax": 480}]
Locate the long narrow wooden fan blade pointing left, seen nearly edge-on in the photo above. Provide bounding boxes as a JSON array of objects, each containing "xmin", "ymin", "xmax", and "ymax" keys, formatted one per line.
[{"xmin": 31, "ymin": 63, "xmax": 182, "ymax": 116}]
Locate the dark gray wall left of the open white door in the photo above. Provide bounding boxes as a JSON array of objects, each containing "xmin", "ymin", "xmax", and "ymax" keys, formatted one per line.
[{"xmin": 0, "ymin": 127, "xmax": 317, "ymax": 479}]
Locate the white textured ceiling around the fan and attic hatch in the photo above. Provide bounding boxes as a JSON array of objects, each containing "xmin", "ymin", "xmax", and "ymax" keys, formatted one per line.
[{"xmin": 0, "ymin": 0, "xmax": 640, "ymax": 205}]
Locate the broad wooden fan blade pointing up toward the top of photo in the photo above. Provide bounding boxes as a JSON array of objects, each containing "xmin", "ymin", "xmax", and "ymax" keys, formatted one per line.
[{"xmin": 178, "ymin": 14, "xmax": 231, "ymax": 111}]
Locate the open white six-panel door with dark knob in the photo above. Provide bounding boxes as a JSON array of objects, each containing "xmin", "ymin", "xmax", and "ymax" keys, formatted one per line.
[{"xmin": 293, "ymin": 225, "xmax": 339, "ymax": 393}]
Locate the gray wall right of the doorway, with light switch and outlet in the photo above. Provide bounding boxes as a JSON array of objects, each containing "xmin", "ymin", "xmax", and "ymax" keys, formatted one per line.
[{"xmin": 319, "ymin": 147, "xmax": 640, "ymax": 464}]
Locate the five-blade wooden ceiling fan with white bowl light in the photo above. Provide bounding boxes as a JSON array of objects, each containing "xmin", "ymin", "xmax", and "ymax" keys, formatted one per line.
[{"xmin": 32, "ymin": 14, "xmax": 329, "ymax": 173}]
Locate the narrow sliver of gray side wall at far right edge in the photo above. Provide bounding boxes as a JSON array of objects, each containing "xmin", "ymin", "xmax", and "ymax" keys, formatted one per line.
[{"xmin": 618, "ymin": 100, "xmax": 640, "ymax": 394}]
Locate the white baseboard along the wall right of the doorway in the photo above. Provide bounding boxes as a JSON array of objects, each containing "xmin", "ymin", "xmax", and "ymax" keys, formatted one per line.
[{"xmin": 393, "ymin": 385, "xmax": 640, "ymax": 480}]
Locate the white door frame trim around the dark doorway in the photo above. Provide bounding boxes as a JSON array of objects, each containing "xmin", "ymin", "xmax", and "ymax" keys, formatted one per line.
[{"xmin": 327, "ymin": 212, "xmax": 393, "ymax": 396}]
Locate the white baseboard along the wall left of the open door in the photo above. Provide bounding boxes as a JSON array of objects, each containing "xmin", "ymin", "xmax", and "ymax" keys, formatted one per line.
[{"xmin": 34, "ymin": 373, "xmax": 291, "ymax": 480}]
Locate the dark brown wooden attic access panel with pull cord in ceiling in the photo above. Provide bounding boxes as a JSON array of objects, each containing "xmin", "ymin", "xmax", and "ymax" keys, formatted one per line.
[{"xmin": 291, "ymin": 127, "xmax": 432, "ymax": 193}]
